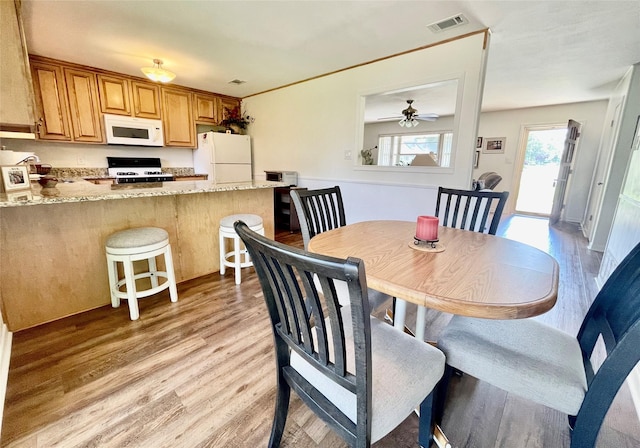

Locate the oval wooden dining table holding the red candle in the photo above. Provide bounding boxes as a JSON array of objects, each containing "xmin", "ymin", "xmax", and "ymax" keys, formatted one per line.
[{"xmin": 308, "ymin": 221, "xmax": 559, "ymax": 339}]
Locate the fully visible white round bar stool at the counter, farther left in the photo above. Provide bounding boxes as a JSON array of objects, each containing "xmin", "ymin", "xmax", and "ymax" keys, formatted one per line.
[{"xmin": 105, "ymin": 227, "xmax": 178, "ymax": 320}]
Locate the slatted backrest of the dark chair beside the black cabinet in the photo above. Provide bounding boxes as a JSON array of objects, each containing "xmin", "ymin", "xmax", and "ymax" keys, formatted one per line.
[{"xmin": 291, "ymin": 186, "xmax": 346, "ymax": 249}]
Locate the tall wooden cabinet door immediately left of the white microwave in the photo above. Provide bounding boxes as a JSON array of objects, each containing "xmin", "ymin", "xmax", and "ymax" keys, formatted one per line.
[{"xmin": 64, "ymin": 68, "xmax": 104, "ymax": 143}]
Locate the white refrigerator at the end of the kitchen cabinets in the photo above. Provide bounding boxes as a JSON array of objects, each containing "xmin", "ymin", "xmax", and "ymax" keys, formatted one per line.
[{"xmin": 193, "ymin": 132, "xmax": 253, "ymax": 183}]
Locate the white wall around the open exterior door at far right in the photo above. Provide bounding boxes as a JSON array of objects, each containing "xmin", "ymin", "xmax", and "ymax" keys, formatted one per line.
[{"xmin": 473, "ymin": 101, "xmax": 607, "ymax": 222}]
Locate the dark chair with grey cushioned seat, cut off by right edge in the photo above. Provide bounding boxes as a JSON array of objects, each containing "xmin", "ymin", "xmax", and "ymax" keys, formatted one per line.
[{"xmin": 437, "ymin": 244, "xmax": 640, "ymax": 448}]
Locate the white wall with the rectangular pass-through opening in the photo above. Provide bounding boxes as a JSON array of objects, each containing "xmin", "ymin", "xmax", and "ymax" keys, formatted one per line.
[{"xmin": 243, "ymin": 34, "xmax": 486, "ymax": 222}]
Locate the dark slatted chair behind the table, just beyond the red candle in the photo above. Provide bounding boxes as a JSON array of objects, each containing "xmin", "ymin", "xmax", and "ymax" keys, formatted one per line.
[{"xmin": 436, "ymin": 187, "xmax": 509, "ymax": 235}]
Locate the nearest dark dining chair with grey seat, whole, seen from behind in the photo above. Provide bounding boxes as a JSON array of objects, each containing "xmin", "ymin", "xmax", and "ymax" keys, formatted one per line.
[{"xmin": 235, "ymin": 221, "xmax": 444, "ymax": 448}]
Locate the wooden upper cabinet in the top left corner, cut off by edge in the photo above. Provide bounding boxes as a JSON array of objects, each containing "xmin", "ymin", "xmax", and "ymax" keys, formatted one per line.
[{"xmin": 0, "ymin": 1, "xmax": 35, "ymax": 132}]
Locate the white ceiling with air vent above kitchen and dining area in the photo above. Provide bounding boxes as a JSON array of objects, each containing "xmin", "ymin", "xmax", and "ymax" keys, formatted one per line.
[{"xmin": 23, "ymin": 0, "xmax": 640, "ymax": 113}]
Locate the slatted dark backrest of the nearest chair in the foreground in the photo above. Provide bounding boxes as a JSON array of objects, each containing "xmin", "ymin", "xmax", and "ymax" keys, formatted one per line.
[{"xmin": 235, "ymin": 222, "xmax": 371, "ymax": 410}]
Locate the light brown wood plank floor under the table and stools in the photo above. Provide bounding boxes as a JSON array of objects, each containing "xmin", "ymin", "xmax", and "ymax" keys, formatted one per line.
[{"xmin": 1, "ymin": 217, "xmax": 640, "ymax": 448}]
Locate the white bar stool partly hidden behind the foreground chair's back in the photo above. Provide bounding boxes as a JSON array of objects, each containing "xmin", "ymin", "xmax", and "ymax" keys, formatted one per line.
[{"xmin": 219, "ymin": 214, "xmax": 264, "ymax": 285}]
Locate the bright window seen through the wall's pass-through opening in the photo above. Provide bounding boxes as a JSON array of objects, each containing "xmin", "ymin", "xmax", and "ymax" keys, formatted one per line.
[{"xmin": 378, "ymin": 131, "xmax": 453, "ymax": 167}]
